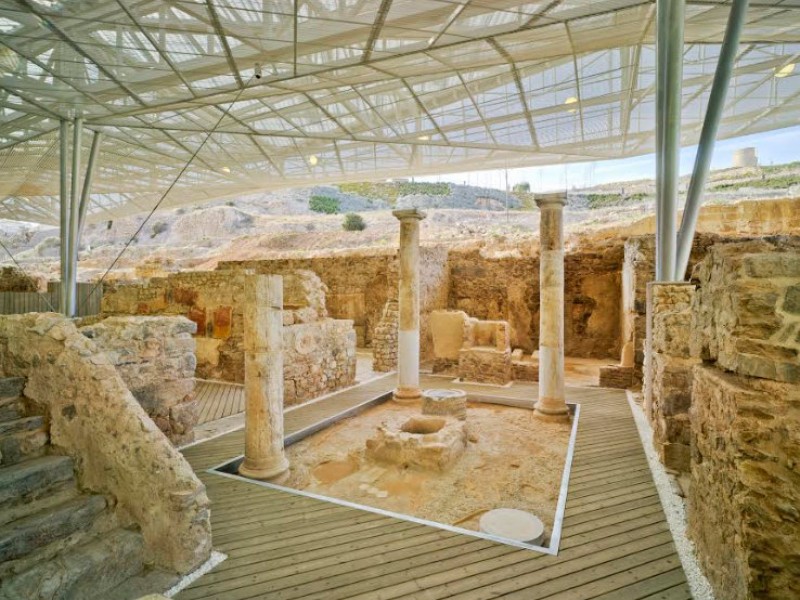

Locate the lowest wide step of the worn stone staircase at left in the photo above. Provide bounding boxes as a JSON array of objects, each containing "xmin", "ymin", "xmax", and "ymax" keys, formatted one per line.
[{"xmin": 0, "ymin": 529, "xmax": 144, "ymax": 600}]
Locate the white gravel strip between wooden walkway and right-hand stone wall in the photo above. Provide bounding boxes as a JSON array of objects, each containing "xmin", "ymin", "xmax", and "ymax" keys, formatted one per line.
[{"xmin": 628, "ymin": 392, "xmax": 714, "ymax": 600}]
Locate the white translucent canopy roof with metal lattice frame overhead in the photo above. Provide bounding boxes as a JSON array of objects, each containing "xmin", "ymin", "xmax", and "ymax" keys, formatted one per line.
[{"xmin": 0, "ymin": 0, "xmax": 800, "ymax": 224}]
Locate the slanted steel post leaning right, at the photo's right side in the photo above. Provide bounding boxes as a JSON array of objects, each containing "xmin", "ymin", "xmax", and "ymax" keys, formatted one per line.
[{"xmin": 675, "ymin": 0, "xmax": 748, "ymax": 280}]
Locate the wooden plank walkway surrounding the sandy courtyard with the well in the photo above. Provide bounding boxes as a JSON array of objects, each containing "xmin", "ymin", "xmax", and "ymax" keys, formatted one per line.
[{"xmin": 177, "ymin": 375, "xmax": 691, "ymax": 600}]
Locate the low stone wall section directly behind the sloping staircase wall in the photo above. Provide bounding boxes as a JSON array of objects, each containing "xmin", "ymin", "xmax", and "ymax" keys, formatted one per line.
[{"xmin": 79, "ymin": 317, "xmax": 198, "ymax": 445}]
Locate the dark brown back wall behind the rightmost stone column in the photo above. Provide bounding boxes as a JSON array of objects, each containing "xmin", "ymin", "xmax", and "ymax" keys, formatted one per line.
[{"xmin": 448, "ymin": 243, "xmax": 623, "ymax": 359}]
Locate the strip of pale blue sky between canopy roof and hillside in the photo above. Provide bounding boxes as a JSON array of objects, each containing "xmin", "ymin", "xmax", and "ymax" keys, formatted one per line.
[{"xmin": 416, "ymin": 126, "xmax": 800, "ymax": 192}]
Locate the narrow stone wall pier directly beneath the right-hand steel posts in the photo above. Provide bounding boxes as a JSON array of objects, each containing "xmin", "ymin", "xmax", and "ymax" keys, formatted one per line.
[{"xmin": 644, "ymin": 283, "xmax": 700, "ymax": 473}]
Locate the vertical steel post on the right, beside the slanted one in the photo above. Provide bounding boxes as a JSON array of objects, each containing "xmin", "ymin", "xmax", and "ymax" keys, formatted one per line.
[{"xmin": 656, "ymin": 0, "xmax": 685, "ymax": 281}]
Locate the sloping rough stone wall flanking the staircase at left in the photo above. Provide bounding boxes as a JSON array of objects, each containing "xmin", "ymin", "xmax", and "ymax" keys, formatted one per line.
[{"xmin": 0, "ymin": 313, "xmax": 212, "ymax": 573}]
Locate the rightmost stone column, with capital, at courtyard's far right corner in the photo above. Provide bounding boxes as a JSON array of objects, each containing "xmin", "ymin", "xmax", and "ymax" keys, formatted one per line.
[{"xmin": 534, "ymin": 192, "xmax": 569, "ymax": 418}]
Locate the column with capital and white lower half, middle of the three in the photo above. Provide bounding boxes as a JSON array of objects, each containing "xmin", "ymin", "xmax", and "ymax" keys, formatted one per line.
[{"xmin": 392, "ymin": 208, "xmax": 425, "ymax": 403}]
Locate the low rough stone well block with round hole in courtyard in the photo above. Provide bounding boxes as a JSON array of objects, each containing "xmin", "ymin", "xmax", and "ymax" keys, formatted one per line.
[{"xmin": 366, "ymin": 415, "xmax": 467, "ymax": 471}]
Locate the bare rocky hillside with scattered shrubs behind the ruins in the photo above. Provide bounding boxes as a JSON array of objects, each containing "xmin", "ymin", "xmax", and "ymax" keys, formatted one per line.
[{"xmin": 0, "ymin": 163, "xmax": 800, "ymax": 280}]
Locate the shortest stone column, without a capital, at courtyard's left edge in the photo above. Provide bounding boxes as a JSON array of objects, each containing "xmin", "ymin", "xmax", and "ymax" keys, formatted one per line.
[{"xmin": 239, "ymin": 275, "xmax": 289, "ymax": 479}]
